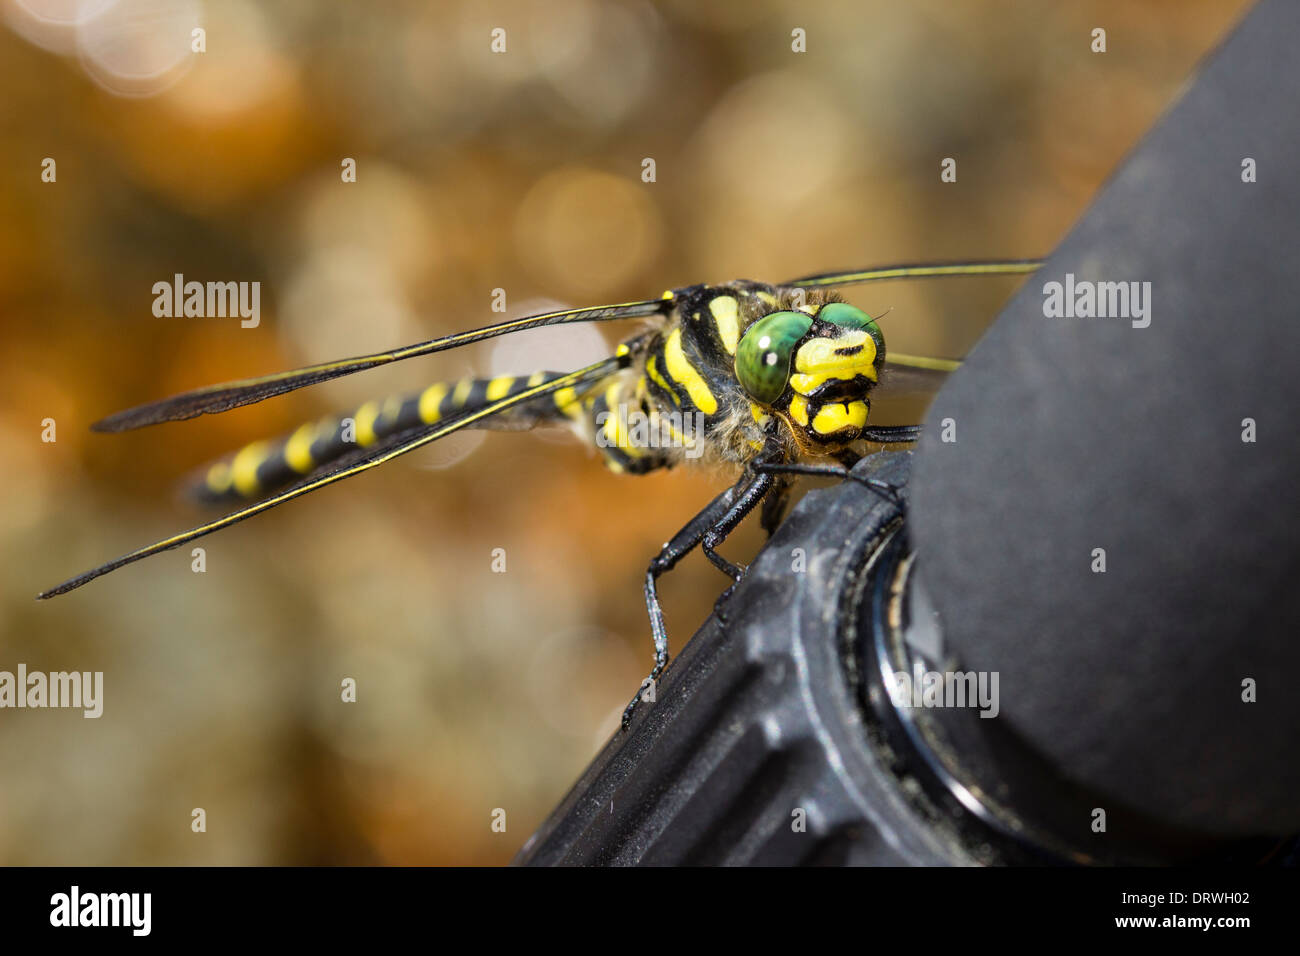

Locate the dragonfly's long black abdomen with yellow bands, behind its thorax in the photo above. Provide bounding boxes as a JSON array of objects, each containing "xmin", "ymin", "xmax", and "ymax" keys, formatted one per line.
[{"xmin": 187, "ymin": 372, "xmax": 577, "ymax": 503}]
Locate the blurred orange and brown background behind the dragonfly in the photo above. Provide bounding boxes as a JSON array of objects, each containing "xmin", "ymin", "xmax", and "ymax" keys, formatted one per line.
[{"xmin": 0, "ymin": 0, "xmax": 1247, "ymax": 865}]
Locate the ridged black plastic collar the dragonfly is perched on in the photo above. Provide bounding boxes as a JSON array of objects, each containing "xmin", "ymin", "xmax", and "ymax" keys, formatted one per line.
[{"xmin": 516, "ymin": 454, "xmax": 971, "ymax": 865}]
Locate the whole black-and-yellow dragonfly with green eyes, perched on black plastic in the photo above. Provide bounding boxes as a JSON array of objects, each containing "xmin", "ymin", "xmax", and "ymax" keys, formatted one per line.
[{"xmin": 38, "ymin": 259, "xmax": 1041, "ymax": 731}]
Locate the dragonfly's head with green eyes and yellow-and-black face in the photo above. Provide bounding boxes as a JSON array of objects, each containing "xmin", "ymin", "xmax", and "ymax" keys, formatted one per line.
[{"xmin": 736, "ymin": 302, "xmax": 885, "ymax": 445}]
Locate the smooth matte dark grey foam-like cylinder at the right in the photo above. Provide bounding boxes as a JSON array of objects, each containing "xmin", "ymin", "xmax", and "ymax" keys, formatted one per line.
[{"xmin": 911, "ymin": 0, "xmax": 1300, "ymax": 836}]
